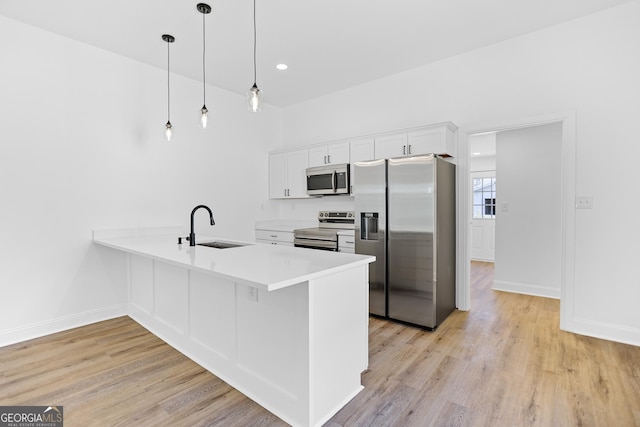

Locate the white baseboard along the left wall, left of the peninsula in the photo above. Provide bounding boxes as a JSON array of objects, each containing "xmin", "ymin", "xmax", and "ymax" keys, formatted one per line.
[{"xmin": 0, "ymin": 304, "xmax": 127, "ymax": 347}]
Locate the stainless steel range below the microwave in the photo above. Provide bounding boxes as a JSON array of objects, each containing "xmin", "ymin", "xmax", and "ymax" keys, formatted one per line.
[{"xmin": 293, "ymin": 211, "xmax": 355, "ymax": 251}]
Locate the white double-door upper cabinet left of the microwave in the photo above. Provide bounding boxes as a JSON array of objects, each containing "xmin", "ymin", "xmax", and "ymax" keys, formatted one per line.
[{"xmin": 269, "ymin": 149, "xmax": 309, "ymax": 199}]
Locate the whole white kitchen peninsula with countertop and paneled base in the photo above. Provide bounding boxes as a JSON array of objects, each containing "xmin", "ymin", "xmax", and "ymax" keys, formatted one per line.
[{"xmin": 94, "ymin": 228, "xmax": 375, "ymax": 426}]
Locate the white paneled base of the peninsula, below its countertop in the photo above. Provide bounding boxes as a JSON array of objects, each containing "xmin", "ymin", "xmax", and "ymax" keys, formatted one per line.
[{"xmin": 127, "ymin": 254, "xmax": 369, "ymax": 427}]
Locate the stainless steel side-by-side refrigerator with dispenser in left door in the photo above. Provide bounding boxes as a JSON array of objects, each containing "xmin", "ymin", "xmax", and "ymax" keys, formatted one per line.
[{"xmin": 353, "ymin": 154, "xmax": 456, "ymax": 329}]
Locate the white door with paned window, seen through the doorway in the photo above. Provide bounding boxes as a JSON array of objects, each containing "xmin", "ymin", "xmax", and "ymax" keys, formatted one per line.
[{"xmin": 471, "ymin": 171, "xmax": 496, "ymax": 262}]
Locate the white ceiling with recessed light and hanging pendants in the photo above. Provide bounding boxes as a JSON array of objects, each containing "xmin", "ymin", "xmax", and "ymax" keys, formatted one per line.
[{"xmin": 0, "ymin": 0, "xmax": 630, "ymax": 107}]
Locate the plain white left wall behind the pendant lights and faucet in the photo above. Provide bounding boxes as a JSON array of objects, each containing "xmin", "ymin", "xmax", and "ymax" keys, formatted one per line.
[{"xmin": 0, "ymin": 17, "xmax": 281, "ymax": 345}]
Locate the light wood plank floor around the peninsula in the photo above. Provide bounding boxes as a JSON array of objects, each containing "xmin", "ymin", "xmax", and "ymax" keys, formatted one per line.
[{"xmin": 0, "ymin": 263, "xmax": 640, "ymax": 427}]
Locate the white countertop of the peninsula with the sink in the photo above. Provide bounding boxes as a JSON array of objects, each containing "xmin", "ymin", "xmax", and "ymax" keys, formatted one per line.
[{"xmin": 93, "ymin": 231, "xmax": 375, "ymax": 291}]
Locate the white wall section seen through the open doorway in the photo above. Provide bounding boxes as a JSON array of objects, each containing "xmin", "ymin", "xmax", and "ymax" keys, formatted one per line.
[{"xmin": 493, "ymin": 123, "xmax": 562, "ymax": 298}]
